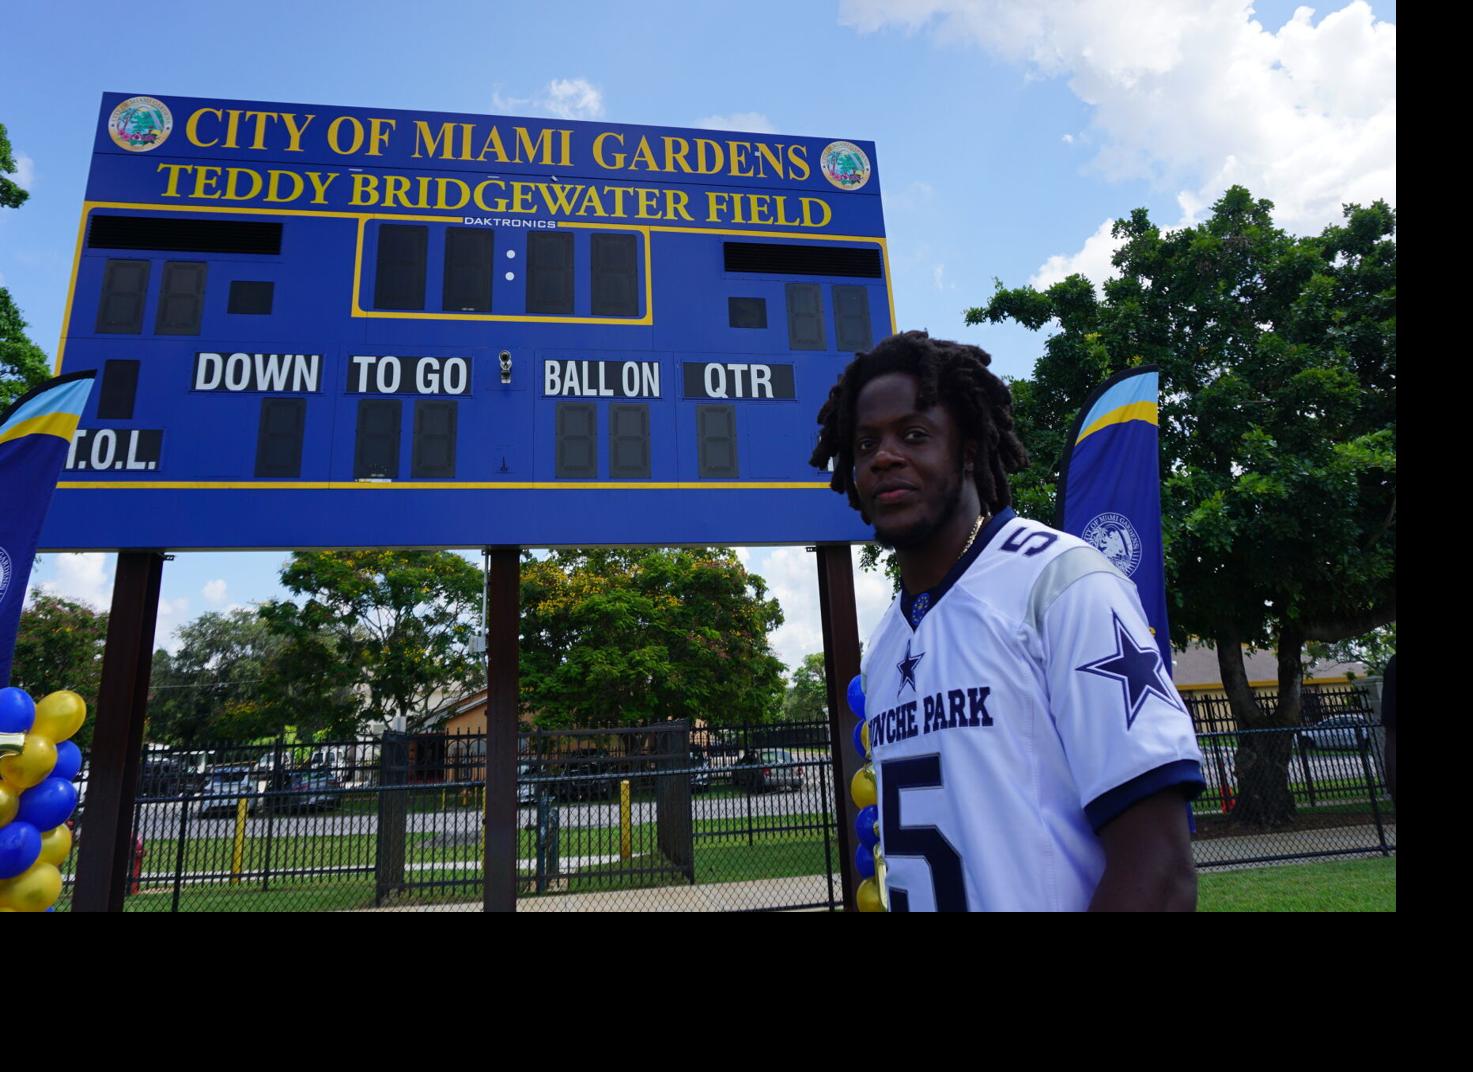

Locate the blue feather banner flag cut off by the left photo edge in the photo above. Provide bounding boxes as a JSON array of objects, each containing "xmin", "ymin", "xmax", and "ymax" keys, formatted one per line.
[{"xmin": 0, "ymin": 371, "xmax": 97, "ymax": 688}]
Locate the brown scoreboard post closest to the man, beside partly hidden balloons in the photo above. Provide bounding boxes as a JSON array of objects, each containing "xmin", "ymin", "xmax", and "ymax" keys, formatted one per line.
[{"xmin": 818, "ymin": 543, "xmax": 863, "ymax": 911}]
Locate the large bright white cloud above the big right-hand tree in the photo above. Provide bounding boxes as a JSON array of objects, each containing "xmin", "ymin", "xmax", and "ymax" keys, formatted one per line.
[{"xmin": 840, "ymin": 0, "xmax": 1396, "ymax": 233}]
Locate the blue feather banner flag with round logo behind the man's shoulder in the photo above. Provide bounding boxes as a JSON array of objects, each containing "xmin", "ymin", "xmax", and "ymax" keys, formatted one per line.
[{"xmin": 1055, "ymin": 365, "xmax": 1171, "ymax": 674}]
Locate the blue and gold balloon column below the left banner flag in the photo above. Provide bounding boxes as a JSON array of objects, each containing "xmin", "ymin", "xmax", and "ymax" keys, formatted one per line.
[{"xmin": 0, "ymin": 688, "xmax": 87, "ymax": 911}]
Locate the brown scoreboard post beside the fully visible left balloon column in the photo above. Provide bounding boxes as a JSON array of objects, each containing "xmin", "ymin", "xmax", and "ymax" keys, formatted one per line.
[{"xmin": 72, "ymin": 551, "xmax": 164, "ymax": 911}]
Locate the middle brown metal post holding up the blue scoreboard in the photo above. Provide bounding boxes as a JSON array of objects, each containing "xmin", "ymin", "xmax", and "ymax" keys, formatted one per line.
[{"xmin": 485, "ymin": 548, "xmax": 521, "ymax": 911}]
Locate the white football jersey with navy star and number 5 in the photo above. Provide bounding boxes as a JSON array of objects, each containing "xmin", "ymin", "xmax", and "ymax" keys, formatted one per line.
[{"xmin": 863, "ymin": 509, "xmax": 1202, "ymax": 911}]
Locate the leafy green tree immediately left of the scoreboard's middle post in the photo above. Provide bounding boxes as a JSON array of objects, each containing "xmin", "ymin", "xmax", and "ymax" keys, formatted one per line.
[{"xmin": 261, "ymin": 551, "xmax": 485, "ymax": 730}]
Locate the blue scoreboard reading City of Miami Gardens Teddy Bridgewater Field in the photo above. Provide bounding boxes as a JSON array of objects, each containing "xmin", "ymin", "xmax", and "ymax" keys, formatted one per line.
[{"xmin": 41, "ymin": 94, "xmax": 894, "ymax": 551}]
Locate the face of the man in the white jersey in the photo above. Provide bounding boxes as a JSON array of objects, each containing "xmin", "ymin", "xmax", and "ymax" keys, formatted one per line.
[{"xmin": 854, "ymin": 373, "xmax": 975, "ymax": 551}]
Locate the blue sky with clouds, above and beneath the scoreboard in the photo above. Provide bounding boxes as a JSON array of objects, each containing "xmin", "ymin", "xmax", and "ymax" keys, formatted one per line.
[{"xmin": 0, "ymin": 0, "xmax": 1396, "ymax": 664}]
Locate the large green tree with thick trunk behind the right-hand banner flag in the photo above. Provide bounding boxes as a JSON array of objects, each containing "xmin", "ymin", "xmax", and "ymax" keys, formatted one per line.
[{"xmin": 966, "ymin": 187, "xmax": 1396, "ymax": 825}]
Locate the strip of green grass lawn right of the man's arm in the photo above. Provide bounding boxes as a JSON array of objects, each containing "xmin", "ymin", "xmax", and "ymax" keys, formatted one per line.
[{"xmin": 1198, "ymin": 857, "xmax": 1396, "ymax": 911}]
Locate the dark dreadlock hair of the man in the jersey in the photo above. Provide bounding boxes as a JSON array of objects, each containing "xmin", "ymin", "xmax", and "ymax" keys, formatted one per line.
[{"xmin": 809, "ymin": 331, "xmax": 1028, "ymax": 523}]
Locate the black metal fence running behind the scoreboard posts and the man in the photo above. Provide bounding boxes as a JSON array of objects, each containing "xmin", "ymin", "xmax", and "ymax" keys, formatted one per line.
[{"xmin": 57, "ymin": 703, "xmax": 1396, "ymax": 911}]
